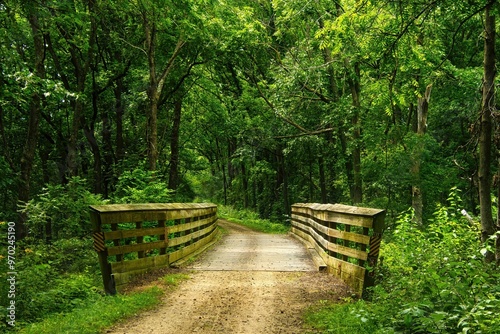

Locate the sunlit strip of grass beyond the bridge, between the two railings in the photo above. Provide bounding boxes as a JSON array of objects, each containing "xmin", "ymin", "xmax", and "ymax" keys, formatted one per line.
[{"xmin": 217, "ymin": 205, "xmax": 290, "ymax": 234}]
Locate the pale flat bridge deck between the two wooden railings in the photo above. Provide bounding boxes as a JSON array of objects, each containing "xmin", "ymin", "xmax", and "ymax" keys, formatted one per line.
[{"xmin": 189, "ymin": 221, "xmax": 317, "ymax": 271}]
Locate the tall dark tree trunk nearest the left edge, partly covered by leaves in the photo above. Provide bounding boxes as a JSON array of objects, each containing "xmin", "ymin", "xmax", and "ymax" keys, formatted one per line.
[{"xmin": 16, "ymin": 11, "xmax": 45, "ymax": 240}]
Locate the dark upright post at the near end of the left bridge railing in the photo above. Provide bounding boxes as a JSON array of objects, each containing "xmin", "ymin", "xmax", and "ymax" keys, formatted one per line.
[{"xmin": 90, "ymin": 210, "xmax": 116, "ymax": 295}]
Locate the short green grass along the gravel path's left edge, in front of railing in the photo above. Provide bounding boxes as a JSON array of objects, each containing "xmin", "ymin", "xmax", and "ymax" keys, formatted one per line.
[{"xmin": 20, "ymin": 287, "xmax": 163, "ymax": 334}]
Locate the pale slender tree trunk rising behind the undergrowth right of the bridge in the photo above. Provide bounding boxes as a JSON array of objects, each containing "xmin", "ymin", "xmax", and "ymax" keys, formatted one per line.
[{"xmin": 411, "ymin": 85, "xmax": 432, "ymax": 226}]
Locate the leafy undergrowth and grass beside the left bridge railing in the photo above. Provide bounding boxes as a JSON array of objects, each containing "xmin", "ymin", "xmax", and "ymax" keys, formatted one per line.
[{"xmin": 0, "ymin": 175, "xmax": 176, "ymax": 333}]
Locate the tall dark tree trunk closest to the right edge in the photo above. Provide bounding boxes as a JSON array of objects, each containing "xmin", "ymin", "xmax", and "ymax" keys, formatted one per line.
[{"xmin": 478, "ymin": 5, "xmax": 496, "ymax": 262}]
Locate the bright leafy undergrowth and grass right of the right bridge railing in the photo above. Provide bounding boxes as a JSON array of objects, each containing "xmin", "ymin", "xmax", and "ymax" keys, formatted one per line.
[{"xmin": 307, "ymin": 191, "xmax": 500, "ymax": 334}]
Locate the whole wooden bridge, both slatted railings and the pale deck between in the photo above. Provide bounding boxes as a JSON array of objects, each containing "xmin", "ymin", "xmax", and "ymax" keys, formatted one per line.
[{"xmin": 90, "ymin": 203, "xmax": 385, "ymax": 296}]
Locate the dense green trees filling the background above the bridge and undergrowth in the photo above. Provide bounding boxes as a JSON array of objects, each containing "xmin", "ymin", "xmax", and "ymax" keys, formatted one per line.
[{"xmin": 0, "ymin": 0, "xmax": 498, "ymax": 250}]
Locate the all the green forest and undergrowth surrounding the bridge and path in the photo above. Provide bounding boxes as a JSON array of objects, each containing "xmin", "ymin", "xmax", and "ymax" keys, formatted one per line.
[{"xmin": 0, "ymin": 0, "xmax": 500, "ymax": 333}]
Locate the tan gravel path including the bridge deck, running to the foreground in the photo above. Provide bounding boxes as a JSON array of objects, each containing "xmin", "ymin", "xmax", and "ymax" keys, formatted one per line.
[{"xmin": 107, "ymin": 221, "xmax": 350, "ymax": 334}]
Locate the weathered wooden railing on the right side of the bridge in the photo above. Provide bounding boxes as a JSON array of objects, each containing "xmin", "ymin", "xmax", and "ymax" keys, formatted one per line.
[{"xmin": 292, "ymin": 203, "xmax": 385, "ymax": 297}]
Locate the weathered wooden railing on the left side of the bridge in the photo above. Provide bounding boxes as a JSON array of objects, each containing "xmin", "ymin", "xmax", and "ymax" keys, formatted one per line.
[{"xmin": 90, "ymin": 203, "xmax": 217, "ymax": 294}]
